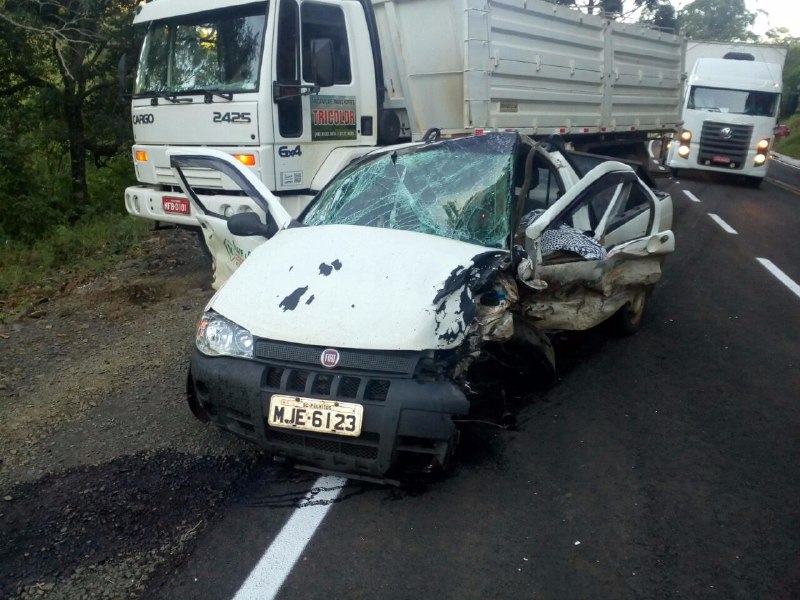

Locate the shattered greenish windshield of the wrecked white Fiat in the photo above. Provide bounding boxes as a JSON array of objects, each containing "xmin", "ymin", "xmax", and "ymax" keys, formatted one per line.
[{"xmin": 303, "ymin": 133, "xmax": 519, "ymax": 248}]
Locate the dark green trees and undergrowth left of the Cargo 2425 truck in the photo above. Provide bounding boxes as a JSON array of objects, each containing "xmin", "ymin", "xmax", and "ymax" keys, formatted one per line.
[{"xmin": 0, "ymin": 0, "xmax": 141, "ymax": 243}]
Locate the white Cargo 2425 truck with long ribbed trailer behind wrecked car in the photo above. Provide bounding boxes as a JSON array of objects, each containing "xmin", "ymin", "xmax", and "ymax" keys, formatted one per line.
[{"xmin": 125, "ymin": 0, "xmax": 685, "ymax": 226}]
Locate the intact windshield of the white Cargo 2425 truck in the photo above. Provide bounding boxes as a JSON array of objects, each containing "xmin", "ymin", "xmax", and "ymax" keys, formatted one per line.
[{"xmin": 134, "ymin": 3, "xmax": 267, "ymax": 96}]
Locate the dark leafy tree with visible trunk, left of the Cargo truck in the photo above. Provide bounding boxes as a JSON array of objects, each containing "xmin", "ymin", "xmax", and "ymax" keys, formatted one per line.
[{"xmin": 0, "ymin": 0, "xmax": 137, "ymax": 226}]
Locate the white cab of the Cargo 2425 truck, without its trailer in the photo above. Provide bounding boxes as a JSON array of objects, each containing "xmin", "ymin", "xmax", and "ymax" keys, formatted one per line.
[{"xmin": 125, "ymin": 0, "xmax": 378, "ymax": 226}]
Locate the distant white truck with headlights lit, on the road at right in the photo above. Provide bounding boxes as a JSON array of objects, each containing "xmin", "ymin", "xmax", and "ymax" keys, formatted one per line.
[{"xmin": 665, "ymin": 42, "xmax": 787, "ymax": 187}]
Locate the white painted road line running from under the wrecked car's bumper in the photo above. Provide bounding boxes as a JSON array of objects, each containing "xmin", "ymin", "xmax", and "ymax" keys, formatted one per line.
[{"xmin": 233, "ymin": 475, "xmax": 347, "ymax": 600}]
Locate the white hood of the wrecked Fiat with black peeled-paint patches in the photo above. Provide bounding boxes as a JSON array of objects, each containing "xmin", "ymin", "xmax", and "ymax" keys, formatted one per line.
[{"xmin": 209, "ymin": 225, "xmax": 506, "ymax": 350}]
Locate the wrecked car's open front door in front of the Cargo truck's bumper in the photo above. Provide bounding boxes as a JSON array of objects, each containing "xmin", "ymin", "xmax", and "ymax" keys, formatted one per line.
[{"xmin": 167, "ymin": 148, "xmax": 292, "ymax": 289}]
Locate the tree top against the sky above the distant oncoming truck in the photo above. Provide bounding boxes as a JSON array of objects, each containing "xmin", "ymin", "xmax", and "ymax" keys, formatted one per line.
[{"xmin": 678, "ymin": 0, "xmax": 757, "ymax": 41}]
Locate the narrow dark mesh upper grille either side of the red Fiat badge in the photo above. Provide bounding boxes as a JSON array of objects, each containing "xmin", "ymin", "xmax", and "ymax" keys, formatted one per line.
[{"xmin": 254, "ymin": 339, "xmax": 420, "ymax": 377}]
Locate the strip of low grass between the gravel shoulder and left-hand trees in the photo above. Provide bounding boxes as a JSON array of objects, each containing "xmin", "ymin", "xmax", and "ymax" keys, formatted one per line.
[{"xmin": 0, "ymin": 214, "xmax": 152, "ymax": 322}]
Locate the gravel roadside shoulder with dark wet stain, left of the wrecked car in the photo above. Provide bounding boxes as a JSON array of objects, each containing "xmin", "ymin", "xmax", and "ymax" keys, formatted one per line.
[{"xmin": 0, "ymin": 230, "xmax": 264, "ymax": 598}]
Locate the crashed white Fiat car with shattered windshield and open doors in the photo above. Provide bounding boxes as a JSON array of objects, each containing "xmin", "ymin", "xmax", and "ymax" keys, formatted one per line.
[{"xmin": 171, "ymin": 133, "xmax": 675, "ymax": 479}]
